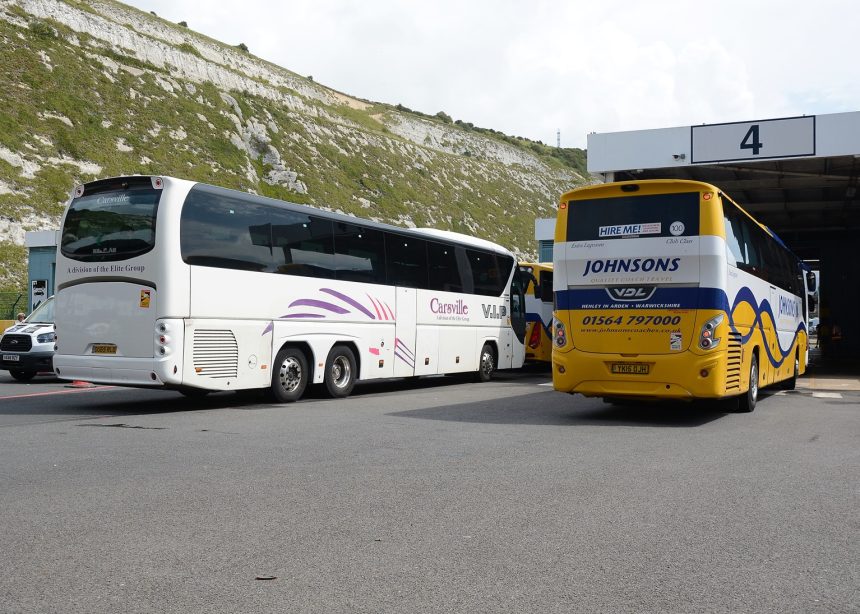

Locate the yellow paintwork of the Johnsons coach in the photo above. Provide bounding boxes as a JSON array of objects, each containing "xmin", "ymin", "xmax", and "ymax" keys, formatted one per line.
[{"xmin": 552, "ymin": 180, "xmax": 809, "ymax": 400}]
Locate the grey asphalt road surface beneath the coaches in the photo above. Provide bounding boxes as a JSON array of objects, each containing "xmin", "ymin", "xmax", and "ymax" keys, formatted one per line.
[{"xmin": 0, "ymin": 372, "xmax": 860, "ymax": 613}]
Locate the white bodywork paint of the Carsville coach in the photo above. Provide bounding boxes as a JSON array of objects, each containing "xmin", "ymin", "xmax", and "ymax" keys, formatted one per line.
[{"xmin": 55, "ymin": 177, "xmax": 525, "ymax": 390}]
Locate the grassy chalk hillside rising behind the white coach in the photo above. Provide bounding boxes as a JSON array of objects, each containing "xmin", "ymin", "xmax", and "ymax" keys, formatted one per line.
[{"xmin": 0, "ymin": 0, "xmax": 585, "ymax": 289}]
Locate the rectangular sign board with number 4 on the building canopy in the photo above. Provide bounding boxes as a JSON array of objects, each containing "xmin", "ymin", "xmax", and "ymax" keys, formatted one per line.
[{"xmin": 690, "ymin": 115, "xmax": 815, "ymax": 164}]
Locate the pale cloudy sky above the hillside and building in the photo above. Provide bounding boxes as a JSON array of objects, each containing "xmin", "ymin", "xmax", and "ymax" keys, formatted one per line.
[{"xmin": 127, "ymin": 0, "xmax": 860, "ymax": 148}]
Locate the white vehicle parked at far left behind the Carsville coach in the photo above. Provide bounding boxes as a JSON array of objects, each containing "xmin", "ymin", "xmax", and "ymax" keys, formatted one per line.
[{"xmin": 0, "ymin": 296, "xmax": 56, "ymax": 382}]
